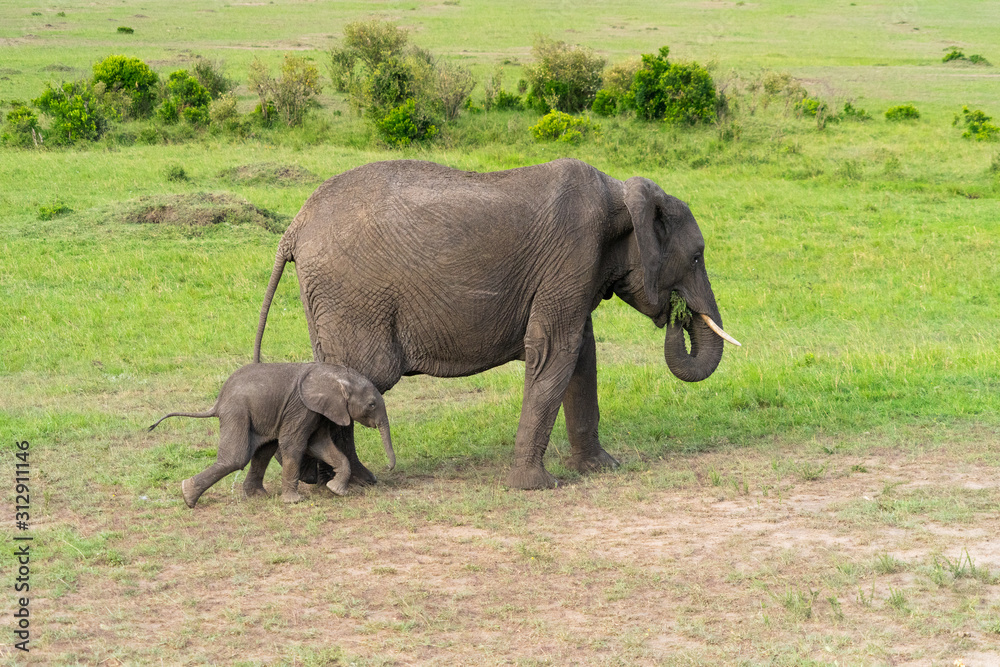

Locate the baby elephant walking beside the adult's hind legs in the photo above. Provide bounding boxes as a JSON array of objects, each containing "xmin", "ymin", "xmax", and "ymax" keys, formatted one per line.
[{"xmin": 149, "ymin": 362, "xmax": 396, "ymax": 507}]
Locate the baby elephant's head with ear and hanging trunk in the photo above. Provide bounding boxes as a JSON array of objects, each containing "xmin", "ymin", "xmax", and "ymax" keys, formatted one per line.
[{"xmin": 299, "ymin": 364, "xmax": 396, "ymax": 470}]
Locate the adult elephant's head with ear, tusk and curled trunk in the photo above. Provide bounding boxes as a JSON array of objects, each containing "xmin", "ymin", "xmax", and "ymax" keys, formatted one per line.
[{"xmin": 616, "ymin": 177, "xmax": 739, "ymax": 382}]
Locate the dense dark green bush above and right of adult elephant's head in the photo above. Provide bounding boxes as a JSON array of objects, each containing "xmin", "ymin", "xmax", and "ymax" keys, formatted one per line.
[{"xmin": 626, "ymin": 46, "xmax": 720, "ymax": 125}]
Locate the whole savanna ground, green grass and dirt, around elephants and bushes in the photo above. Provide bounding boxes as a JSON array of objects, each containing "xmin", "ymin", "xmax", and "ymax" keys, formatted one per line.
[{"xmin": 0, "ymin": 0, "xmax": 1000, "ymax": 667}]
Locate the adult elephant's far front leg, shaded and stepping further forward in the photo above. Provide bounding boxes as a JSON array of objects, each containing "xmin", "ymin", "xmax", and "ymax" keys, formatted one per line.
[{"xmin": 563, "ymin": 316, "xmax": 618, "ymax": 473}]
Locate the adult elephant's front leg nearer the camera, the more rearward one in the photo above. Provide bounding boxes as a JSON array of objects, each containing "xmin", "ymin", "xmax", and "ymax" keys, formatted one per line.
[{"xmin": 507, "ymin": 323, "xmax": 580, "ymax": 489}]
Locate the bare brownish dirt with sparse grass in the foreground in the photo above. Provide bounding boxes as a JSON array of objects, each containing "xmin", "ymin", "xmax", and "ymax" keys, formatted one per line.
[{"xmin": 7, "ymin": 446, "xmax": 1000, "ymax": 667}]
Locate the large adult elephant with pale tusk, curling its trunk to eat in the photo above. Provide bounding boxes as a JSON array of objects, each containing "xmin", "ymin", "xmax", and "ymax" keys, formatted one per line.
[{"xmin": 254, "ymin": 159, "xmax": 740, "ymax": 489}]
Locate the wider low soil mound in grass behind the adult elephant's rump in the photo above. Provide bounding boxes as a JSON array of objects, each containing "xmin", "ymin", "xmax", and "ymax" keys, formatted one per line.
[{"xmin": 125, "ymin": 193, "xmax": 285, "ymax": 233}]
